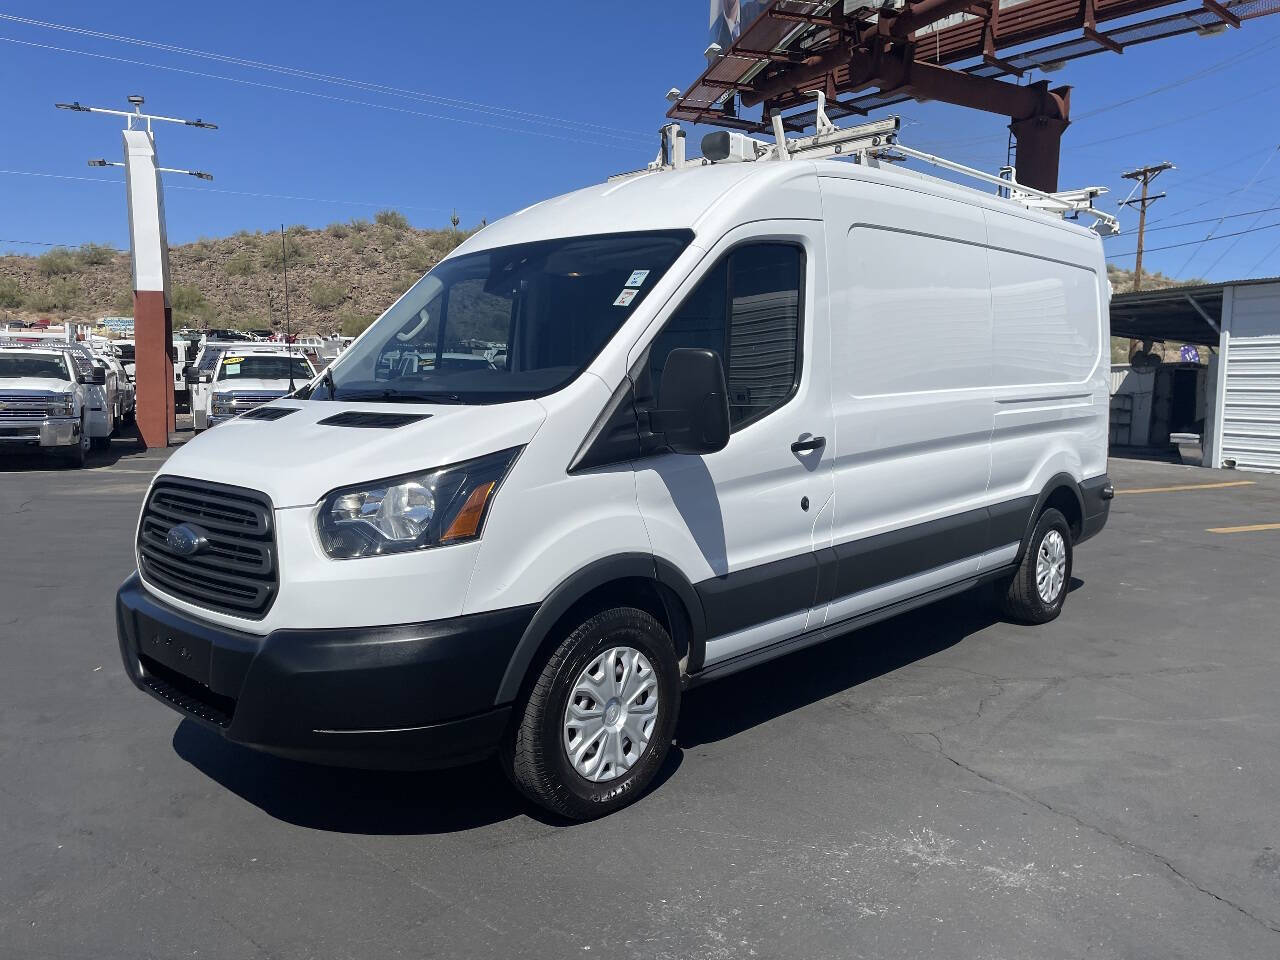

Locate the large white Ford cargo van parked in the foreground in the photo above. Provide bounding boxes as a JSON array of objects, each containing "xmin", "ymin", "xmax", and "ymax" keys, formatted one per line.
[{"xmin": 116, "ymin": 138, "xmax": 1112, "ymax": 818}]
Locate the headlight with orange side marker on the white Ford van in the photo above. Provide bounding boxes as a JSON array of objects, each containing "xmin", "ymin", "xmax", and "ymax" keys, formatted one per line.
[{"xmin": 316, "ymin": 447, "xmax": 520, "ymax": 559}]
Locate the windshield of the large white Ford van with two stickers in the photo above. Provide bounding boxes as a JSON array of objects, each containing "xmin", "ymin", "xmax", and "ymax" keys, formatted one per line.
[{"xmin": 315, "ymin": 230, "xmax": 692, "ymax": 403}]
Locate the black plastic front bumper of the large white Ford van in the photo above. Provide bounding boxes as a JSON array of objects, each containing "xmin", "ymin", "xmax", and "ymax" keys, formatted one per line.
[{"xmin": 115, "ymin": 573, "xmax": 535, "ymax": 769}]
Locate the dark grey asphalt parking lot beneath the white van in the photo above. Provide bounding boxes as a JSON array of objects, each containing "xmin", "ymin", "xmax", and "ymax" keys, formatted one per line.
[{"xmin": 0, "ymin": 444, "xmax": 1280, "ymax": 960}]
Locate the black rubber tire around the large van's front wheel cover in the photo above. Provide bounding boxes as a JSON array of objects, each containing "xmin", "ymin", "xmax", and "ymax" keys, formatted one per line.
[{"xmin": 502, "ymin": 607, "xmax": 680, "ymax": 820}]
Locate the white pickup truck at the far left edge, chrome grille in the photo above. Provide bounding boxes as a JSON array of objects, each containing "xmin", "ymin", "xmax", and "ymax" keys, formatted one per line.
[{"xmin": 0, "ymin": 342, "xmax": 105, "ymax": 467}]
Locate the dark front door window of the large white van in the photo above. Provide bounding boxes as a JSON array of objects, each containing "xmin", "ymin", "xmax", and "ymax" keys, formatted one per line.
[{"xmin": 649, "ymin": 243, "xmax": 804, "ymax": 428}]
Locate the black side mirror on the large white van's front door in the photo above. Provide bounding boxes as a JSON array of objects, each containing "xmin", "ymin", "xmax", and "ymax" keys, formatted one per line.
[{"xmin": 650, "ymin": 347, "xmax": 728, "ymax": 454}]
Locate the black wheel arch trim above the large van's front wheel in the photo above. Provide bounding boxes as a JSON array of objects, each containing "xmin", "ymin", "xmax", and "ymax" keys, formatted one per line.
[{"xmin": 494, "ymin": 553, "xmax": 707, "ymax": 704}]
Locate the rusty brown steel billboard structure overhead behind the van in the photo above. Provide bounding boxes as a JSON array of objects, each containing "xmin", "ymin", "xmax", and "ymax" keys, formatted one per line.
[{"xmin": 667, "ymin": 0, "xmax": 1280, "ymax": 191}]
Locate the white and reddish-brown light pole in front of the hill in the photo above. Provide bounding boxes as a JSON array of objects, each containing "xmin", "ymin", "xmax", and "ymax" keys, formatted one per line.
[{"xmin": 55, "ymin": 96, "xmax": 218, "ymax": 447}]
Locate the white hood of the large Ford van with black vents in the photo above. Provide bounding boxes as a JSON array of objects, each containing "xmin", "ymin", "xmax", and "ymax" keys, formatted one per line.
[{"xmin": 157, "ymin": 399, "xmax": 547, "ymax": 508}]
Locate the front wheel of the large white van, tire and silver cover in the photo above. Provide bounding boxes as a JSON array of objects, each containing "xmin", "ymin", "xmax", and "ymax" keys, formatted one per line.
[{"xmin": 503, "ymin": 607, "xmax": 680, "ymax": 820}]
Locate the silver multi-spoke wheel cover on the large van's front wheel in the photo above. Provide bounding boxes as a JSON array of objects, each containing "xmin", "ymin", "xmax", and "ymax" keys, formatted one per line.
[{"xmin": 563, "ymin": 646, "xmax": 658, "ymax": 783}]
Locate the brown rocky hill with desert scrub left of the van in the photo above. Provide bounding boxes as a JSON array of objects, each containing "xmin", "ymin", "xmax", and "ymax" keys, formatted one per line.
[{"xmin": 0, "ymin": 210, "xmax": 470, "ymax": 334}]
